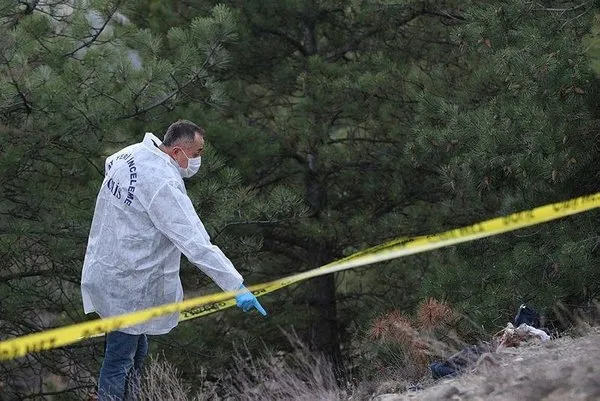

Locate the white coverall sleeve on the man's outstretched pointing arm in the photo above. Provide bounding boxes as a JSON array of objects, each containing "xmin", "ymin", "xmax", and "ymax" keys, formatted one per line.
[{"xmin": 148, "ymin": 182, "xmax": 243, "ymax": 291}]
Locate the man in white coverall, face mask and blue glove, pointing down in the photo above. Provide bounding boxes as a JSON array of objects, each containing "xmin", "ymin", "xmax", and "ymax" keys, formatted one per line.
[{"xmin": 81, "ymin": 120, "xmax": 266, "ymax": 401}]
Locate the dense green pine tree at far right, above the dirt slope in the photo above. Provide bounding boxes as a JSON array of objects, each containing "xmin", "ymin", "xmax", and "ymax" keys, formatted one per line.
[{"xmin": 406, "ymin": 1, "xmax": 599, "ymax": 332}]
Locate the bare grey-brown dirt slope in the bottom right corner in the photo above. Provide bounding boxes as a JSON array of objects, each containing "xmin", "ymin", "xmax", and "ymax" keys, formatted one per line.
[{"xmin": 374, "ymin": 328, "xmax": 600, "ymax": 401}]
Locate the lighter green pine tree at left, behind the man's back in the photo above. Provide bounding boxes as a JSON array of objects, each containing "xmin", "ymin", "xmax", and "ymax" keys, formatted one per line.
[{"xmin": 0, "ymin": 0, "xmax": 255, "ymax": 399}]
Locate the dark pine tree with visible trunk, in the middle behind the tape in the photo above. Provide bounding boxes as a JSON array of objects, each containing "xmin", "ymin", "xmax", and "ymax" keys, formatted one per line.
[{"xmin": 125, "ymin": 1, "xmax": 468, "ymax": 376}]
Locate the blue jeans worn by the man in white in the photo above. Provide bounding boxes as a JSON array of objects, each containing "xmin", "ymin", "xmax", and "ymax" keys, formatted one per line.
[{"xmin": 98, "ymin": 331, "xmax": 148, "ymax": 401}]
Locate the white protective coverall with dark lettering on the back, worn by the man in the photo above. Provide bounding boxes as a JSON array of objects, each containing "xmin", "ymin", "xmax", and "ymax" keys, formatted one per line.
[{"xmin": 81, "ymin": 133, "xmax": 243, "ymax": 335}]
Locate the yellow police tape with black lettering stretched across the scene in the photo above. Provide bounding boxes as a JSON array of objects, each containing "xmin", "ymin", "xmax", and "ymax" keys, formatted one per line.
[{"xmin": 0, "ymin": 193, "xmax": 600, "ymax": 360}]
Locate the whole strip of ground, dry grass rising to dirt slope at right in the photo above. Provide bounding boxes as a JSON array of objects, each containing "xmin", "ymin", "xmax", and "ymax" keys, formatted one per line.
[{"xmin": 135, "ymin": 327, "xmax": 600, "ymax": 401}]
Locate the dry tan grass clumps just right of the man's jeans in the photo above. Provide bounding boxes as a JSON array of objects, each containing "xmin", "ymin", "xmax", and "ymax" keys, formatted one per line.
[{"xmin": 131, "ymin": 336, "xmax": 348, "ymax": 401}]
